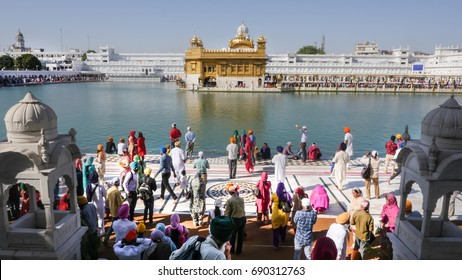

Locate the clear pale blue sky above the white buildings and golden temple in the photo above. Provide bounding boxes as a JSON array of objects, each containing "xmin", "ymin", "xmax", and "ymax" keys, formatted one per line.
[{"xmin": 0, "ymin": 0, "xmax": 462, "ymax": 54}]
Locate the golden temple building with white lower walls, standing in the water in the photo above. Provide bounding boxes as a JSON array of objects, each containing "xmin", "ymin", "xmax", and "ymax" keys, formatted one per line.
[{"xmin": 184, "ymin": 23, "xmax": 266, "ymax": 89}]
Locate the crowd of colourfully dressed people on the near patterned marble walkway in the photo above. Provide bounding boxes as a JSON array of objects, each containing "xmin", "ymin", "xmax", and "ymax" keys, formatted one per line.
[{"xmin": 8, "ymin": 123, "xmax": 418, "ymax": 260}]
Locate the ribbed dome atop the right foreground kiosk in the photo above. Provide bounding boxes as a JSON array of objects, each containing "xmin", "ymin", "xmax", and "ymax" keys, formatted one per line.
[{"xmin": 421, "ymin": 96, "xmax": 462, "ymax": 147}]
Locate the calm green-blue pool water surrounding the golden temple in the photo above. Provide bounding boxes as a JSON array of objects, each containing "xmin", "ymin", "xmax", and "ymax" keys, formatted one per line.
[{"xmin": 0, "ymin": 82, "xmax": 454, "ymax": 158}]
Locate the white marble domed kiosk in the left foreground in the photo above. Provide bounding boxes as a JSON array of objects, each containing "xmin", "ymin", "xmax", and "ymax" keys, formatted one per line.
[{"xmin": 0, "ymin": 92, "xmax": 86, "ymax": 259}]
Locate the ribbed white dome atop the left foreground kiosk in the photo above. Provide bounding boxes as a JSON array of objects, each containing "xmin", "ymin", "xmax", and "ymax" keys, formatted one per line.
[{"xmin": 4, "ymin": 92, "xmax": 58, "ymax": 143}]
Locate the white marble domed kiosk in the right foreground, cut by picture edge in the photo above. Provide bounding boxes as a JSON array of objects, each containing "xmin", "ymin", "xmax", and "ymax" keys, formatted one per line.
[{"xmin": 389, "ymin": 96, "xmax": 462, "ymax": 260}]
